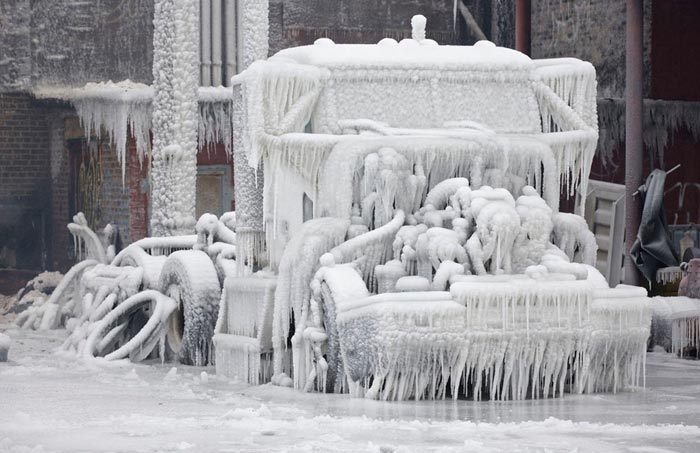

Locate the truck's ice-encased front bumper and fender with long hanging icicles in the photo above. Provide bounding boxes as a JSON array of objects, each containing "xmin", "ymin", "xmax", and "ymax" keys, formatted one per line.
[{"xmin": 306, "ymin": 263, "xmax": 650, "ymax": 400}]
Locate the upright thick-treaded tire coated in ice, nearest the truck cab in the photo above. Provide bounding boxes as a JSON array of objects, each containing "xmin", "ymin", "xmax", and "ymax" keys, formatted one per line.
[{"xmin": 159, "ymin": 250, "xmax": 221, "ymax": 366}]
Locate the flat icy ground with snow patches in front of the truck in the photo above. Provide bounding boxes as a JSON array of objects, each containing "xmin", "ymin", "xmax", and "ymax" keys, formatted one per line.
[{"xmin": 0, "ymin": 317, "xmax": 700, "ymax": 452}]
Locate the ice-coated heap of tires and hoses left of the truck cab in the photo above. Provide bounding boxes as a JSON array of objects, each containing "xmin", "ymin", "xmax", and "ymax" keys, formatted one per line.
[{"xmin": 21, "ymin": 209, "xmax": 236, "ymax": 366}]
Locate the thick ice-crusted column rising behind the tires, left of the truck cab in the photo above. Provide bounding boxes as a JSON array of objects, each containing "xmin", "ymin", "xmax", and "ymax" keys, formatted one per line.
[{"xmin": 151, "ymin": 0, "xmax": 199, "ymax": 236}]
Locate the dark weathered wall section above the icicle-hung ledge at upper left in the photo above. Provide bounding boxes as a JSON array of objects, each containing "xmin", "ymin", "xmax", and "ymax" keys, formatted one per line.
[{"xmin": 0, "ymin": 0, "xmax": 154, "ymax": 91}]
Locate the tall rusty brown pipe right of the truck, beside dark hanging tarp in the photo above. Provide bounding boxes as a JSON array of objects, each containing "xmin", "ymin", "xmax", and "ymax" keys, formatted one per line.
[{"xmin": 625, "ymin": 0, "xmax": 644, "ymax": 285}]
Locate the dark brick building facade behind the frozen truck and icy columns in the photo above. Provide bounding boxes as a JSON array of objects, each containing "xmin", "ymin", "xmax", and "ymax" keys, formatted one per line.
[{"xmin": 0, "ymin": 0, "xmax": 700, "ymax": 276}]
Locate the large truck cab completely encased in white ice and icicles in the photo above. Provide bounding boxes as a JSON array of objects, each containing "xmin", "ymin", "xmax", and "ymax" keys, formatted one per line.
[{"xmin": 214, "ymin": 17, "xmax": 650, "ymax": 399}]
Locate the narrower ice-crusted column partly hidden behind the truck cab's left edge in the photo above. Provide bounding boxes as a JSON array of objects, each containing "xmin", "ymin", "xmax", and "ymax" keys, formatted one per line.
[{"xmin": 233, "ymin": 0, "xmax": 269, "ymax": 268}]
